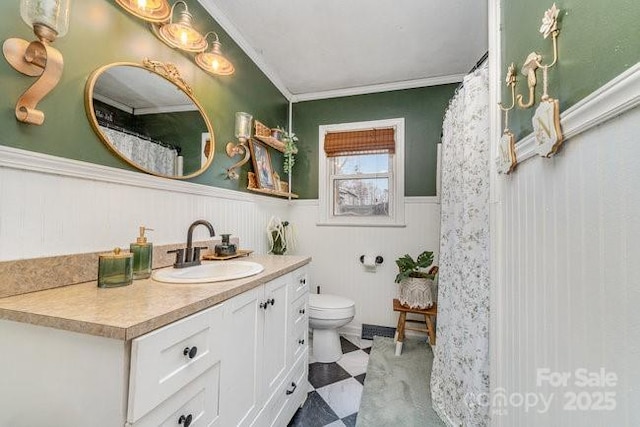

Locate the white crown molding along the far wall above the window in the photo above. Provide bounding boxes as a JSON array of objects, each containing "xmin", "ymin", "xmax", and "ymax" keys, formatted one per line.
[{"xmin": 291, "ymin": 74, "xmax": 466, "ymax": 102}]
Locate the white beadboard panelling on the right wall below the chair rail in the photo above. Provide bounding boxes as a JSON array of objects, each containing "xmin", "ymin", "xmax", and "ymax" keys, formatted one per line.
[{"xmin": 492, "ymin": 107, "xmax": 640, "ymax": 426}]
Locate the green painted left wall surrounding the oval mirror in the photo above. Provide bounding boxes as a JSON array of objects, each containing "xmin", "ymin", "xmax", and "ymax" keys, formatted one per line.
[{"xmin": 0, "ymin": 0, "xmax": 288, "ymax": 190}]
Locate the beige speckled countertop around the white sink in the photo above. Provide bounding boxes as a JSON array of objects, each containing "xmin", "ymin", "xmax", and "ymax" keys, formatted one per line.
[{"xmin": 0, "ymin": 255, "xmax": 311, "ymax": 340}]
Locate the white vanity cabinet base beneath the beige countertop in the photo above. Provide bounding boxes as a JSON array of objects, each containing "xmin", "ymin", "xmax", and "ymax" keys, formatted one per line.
[{"xmin": 0, "ymin": 267, "xmax": 308, "ymax": 427}]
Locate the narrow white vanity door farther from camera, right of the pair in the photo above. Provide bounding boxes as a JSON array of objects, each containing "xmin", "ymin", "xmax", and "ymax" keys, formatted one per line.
[{"xmin": 262, "ymin": 274, "xmax": 291, "ymax": 400}]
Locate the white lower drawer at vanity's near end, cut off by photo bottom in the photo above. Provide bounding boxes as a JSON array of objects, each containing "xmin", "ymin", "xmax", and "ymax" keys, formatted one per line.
[{"xmin": 133, "ymin": 363, "xmax": 220, "ymax": 427}]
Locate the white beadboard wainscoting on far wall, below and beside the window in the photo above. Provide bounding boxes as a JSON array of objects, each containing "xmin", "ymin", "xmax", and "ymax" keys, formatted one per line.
[{"xmin": 288, "ymin": 197, "xmax": 440, "ymax": 335}]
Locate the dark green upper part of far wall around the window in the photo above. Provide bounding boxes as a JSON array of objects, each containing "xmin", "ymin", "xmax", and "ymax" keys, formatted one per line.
[{"xmin": 292, "ymin": 84, "xmax": 458, "ymax": 199}]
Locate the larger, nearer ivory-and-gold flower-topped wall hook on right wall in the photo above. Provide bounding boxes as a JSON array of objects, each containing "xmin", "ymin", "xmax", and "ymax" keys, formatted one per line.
[{"xmin": 532, "ymin": 3, "xmax": 564, "ymax": 157}]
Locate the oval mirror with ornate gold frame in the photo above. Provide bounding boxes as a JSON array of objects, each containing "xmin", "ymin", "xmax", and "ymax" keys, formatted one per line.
[{"xmin": 85, "ymin": 59, "xmax": 215, "ymax": 179}]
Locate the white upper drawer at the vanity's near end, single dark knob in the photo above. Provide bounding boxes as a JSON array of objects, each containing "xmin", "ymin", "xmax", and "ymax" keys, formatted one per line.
[{"xmin": 127, "ymin": 304, "xmax": 224, "ymax": 423}]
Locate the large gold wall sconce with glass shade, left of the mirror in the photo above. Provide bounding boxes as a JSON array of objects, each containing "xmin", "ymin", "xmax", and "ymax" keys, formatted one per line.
[{"xmin": 2, "ymin": 0, "xmax": 70, "ymax": 125}]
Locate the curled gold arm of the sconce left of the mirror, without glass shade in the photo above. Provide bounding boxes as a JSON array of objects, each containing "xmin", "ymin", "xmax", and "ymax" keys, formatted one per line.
[{"xmin": 2, "ymin": 38, "xmax": 64, "ymax": 125}]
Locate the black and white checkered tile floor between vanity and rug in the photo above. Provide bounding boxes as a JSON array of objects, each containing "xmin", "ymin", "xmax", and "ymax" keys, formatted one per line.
[{"xmin": 289, "ymin": 336, "xmax": 373, "ymax": 427}]
